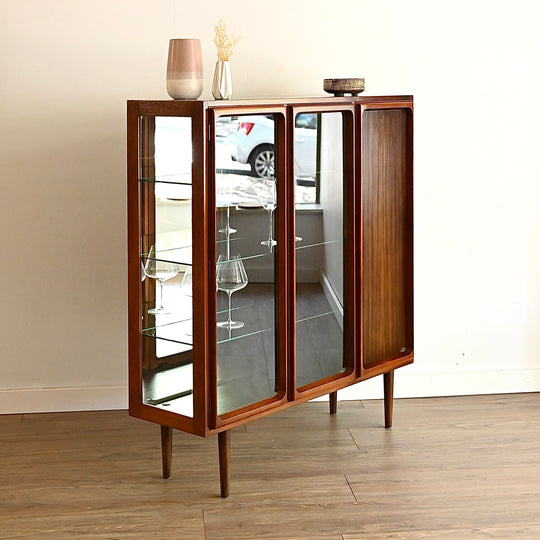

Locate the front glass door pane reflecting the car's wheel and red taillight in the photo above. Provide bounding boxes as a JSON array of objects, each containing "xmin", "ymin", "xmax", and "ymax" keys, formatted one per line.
[{"xmin": 215, "ymin": 114, "xmax": 279, "ymax": 415}]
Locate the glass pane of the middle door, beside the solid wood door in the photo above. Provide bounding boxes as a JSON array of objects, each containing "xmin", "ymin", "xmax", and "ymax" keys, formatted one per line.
[{"xmin": 294, "ymin": 112, "xmax": 347, "ymax": 388}]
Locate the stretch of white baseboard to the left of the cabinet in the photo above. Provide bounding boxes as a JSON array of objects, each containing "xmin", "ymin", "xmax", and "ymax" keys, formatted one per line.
[{"xmin": 0, "ymin": 386, "xmax": 128, "ymax": 414}]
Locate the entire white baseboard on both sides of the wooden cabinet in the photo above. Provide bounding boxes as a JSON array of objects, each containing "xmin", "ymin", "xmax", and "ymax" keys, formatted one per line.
[{"xmin": 0, "ymin": 366, "xmax": 540, "ymax": 414}]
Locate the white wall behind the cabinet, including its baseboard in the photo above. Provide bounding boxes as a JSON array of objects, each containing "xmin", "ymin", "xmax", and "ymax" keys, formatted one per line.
[{"xmin": 0, "ymin": 0, "xmax": 540, "ymax": 412}]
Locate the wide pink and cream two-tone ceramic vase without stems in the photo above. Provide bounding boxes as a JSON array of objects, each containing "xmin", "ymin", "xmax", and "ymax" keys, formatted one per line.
[{"xmin": 167, "ymin": 39, "xmax": 203, "ymax": 99}]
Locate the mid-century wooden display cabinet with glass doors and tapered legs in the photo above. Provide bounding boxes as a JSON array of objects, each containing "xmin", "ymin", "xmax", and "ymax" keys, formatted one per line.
[{"xmin": 127, "ymin": 96, "xmax": 413, "ymax": 497}]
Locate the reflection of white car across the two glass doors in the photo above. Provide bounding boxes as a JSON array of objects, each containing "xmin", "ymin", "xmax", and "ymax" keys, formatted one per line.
[{"xmin": 229, "ymin": 114, "xmax": 317, "ymax": 181}]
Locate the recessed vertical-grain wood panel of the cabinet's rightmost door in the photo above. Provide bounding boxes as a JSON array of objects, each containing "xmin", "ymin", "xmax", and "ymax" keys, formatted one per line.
[{"xmin": 361, "ymin": 109, "xmax": 413, "ymax": 368}]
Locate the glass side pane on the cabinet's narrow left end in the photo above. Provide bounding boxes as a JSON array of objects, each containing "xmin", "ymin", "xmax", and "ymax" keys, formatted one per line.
[{"xmin": 140, "ymin": 116, "xmax": 193, "ymax": 417}]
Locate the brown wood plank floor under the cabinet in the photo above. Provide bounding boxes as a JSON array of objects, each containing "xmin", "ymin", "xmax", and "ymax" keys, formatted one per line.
[{"xmin": 0, "ymin": 392, "xmax": 540, "ymax": 540}]
